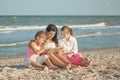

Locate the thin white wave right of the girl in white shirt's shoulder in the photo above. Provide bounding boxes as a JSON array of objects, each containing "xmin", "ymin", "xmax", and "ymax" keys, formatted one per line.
[{"xmin": 75, "ymin": 32, "xmax": 120, "ymax": 38}]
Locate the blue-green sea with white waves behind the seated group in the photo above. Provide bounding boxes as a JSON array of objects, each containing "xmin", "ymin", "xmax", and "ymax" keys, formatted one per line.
[{"xmin": 0, "ymin": 15, "xmax": 120, "ymax": 58}]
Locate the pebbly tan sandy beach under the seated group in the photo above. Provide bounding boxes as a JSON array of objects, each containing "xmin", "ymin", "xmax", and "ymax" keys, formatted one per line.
[{"xmin": 0, "ymin": 48, "xmax": 120, "ymax": 80}]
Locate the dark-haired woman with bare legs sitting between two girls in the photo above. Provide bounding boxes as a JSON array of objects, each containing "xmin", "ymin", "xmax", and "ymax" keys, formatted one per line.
[{"xmin": 45, "ymin": 24, "xmax": 71, "ymax": 70}]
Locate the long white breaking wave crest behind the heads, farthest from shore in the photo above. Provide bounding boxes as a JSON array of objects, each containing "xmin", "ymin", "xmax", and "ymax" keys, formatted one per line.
[{"xmin": 0, "ymin": 22, "xmax": 106, "ymax": 31}]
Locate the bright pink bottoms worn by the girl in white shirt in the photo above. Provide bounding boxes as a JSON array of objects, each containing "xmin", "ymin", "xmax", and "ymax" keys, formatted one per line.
[{"xmin": 64, "ymin": 53, "xmax": 84, "ymax": 66}]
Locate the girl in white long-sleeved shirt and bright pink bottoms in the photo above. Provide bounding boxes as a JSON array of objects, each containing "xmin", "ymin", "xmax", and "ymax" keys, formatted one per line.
[{"xmin": 58, "ymin": 26, "xmax": 91, "ymax": 66}]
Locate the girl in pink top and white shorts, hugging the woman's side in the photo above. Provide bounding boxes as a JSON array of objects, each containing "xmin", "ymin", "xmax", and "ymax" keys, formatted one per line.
[{"xmin": 23, "ymin": 31, "xmax": 55, "ymax": 70}]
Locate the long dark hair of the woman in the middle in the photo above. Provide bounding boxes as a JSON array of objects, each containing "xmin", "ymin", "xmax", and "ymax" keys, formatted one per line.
[{"xmin": 46, "ymin": 24, "xmax": 58, "ymax": 44}]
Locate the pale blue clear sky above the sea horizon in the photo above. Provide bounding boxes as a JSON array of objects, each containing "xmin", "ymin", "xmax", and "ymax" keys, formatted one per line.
[{"xmin": 0, "ymin": 0, "xmax": 120, "ymax": 15}]
